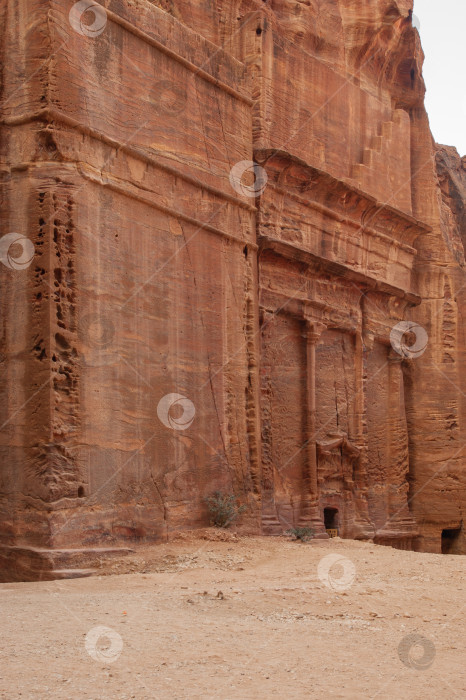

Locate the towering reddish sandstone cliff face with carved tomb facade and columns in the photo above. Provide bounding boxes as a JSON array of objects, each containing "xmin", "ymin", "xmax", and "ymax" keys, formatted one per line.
[{"xmin": 0, "ymin": 0, "xmax": 466, "ymax": 579}]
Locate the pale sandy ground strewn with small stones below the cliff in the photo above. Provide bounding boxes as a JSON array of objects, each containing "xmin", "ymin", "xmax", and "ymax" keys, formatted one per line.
[{"xmin": 0, "ymin": 531, "xmax": 466, "ymax": 700}]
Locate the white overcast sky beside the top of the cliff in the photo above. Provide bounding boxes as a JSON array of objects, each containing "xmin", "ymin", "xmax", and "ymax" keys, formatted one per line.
[{"xmin": 414, "ymin": 0, "xmax": 466, "ymax": 156}]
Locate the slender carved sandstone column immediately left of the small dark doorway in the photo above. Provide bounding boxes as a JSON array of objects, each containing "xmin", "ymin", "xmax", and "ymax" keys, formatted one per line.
[{"xmin": 299, "ymin": 318, "xmax": 328, "ymax": 539}]
